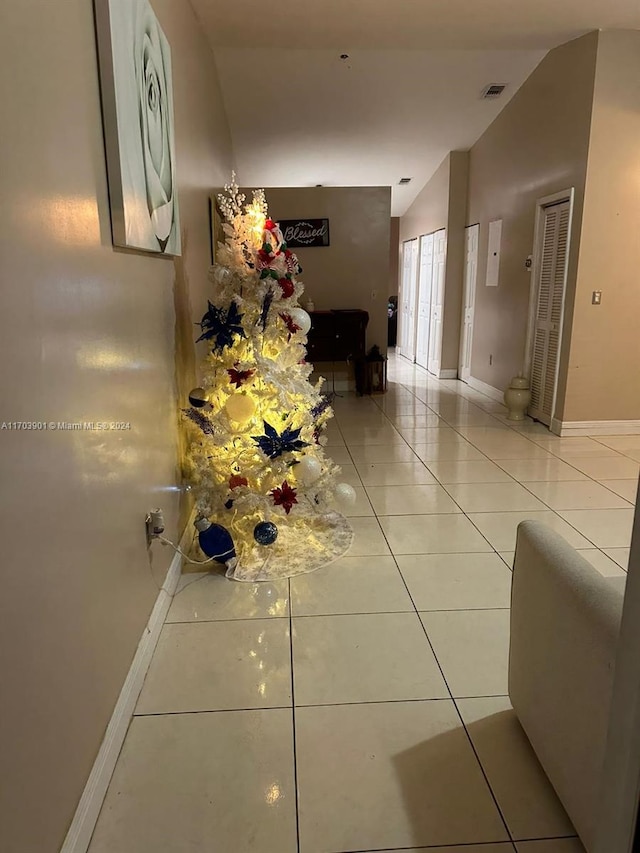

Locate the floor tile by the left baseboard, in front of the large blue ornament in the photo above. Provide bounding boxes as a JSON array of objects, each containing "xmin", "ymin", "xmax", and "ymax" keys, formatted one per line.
[{"xmin": 166, "ymin": 569, "xmax": 289, "ymax": 622}]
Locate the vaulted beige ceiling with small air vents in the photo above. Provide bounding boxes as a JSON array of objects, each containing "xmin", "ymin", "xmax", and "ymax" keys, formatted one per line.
[{"xmin": 191, "ymin": 0, "xmax": 640, "ymax": 216}]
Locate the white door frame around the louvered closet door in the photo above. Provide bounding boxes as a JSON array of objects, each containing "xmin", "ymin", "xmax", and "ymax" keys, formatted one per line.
[{"xmin": 523, "ymin": 187, "xmax": 575, "ymax": 427}]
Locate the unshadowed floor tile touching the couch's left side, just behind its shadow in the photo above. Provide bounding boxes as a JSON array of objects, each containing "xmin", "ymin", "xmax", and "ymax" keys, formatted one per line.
[{"xmin": 420, "ymin": 610, "xmax": 509, "ymax": 697}]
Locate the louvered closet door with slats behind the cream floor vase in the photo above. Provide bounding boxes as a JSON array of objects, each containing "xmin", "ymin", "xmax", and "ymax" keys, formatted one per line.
[{"xmin": 529, "ymin": 201, "xmax": 569, "ymax": 426}]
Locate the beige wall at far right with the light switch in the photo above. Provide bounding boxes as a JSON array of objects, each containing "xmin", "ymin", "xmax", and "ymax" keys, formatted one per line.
[{"xmin": 563, "ymin": 31, "xmax": 640, "ymax": 421}]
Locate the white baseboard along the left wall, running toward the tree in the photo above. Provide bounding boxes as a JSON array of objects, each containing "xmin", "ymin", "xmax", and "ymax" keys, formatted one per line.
[{"xmin": 60, "ymin": 519, "xmax": 192, "ymax": 853}]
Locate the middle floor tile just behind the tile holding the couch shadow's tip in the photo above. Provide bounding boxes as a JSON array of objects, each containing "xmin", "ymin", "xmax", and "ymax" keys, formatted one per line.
[{"xmin": 293, "ymin": 612, "xmax": 449, "ymax": 705}]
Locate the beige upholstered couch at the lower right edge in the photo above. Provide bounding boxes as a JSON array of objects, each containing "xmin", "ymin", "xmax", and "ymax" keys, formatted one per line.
[{"xmin": 509, "ymin": 521, "xmax": 625, "ymax": 851}]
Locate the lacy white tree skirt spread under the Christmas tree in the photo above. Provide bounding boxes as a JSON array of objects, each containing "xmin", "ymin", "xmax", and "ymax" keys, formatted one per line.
[{"xmin": 227, "ymin": 512, "xmax": 353, "ymax": 582}]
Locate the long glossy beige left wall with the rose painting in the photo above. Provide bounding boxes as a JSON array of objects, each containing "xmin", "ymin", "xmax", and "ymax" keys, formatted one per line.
[{"xmin": 0, "ymin": 0, "xmax": 231, "ymax": 853}]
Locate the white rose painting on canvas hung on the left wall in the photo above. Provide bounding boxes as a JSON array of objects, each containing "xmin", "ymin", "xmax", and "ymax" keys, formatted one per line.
[{"xmin": 95, "ymin": 0, "xmax": 180, "ymax": 255}]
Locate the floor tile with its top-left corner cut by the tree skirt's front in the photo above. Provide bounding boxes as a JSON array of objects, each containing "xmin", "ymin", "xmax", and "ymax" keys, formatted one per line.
[{"xmin": 291, "ymin": 557, "xmax": 414, "ymax": 616}]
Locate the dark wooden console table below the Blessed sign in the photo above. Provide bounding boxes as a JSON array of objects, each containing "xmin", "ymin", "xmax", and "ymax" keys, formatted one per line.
[{"xmin": 307, "ymin": 308, "xmax": 369, "ymax": 364}]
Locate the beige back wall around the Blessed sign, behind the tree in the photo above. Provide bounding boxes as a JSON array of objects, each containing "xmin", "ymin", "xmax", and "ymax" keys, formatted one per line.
[{"xmin": 266, "ymin": 187, "xmax": 391, "ymax": 353}]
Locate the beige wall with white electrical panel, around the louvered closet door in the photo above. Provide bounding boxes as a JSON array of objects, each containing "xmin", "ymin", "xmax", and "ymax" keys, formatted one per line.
[{"xmin": 467, "ymin": 33, "xmax": 598, "ymax": 394}]
